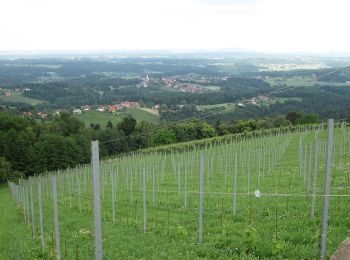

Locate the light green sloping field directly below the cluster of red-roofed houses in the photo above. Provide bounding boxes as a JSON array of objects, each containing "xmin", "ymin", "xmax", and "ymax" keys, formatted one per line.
[{"xmin": 77, "ymin": 107, "xmax": 160, "ymax": 128}]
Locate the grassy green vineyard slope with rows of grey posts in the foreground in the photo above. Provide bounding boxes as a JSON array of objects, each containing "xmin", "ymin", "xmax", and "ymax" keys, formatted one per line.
[{"xmin": 9, "ymin": 123, "xmax": 350, "ymax": 259}]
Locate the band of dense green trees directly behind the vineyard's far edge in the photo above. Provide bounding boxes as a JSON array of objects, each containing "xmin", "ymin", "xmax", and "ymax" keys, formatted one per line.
[{"xmin": 0, "ymin": 111, "xmax": 320, "ymax": 183}]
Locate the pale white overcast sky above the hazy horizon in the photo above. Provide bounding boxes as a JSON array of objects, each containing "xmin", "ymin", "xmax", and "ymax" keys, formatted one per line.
[{"xmin": 0, "ymin": 0, "xmax": 350, "ymax": 53}]
